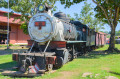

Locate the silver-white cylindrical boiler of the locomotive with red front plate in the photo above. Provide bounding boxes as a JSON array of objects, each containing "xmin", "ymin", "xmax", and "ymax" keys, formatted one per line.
[{"xmin": 28, "ymin": 8, "xmax": 77, "ymax": 43}]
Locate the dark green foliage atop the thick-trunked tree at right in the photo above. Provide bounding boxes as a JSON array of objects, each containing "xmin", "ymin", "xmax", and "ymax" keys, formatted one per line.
[{"xmin": 94, "ymin": 0, "xmax": 120, "ymax": 26}]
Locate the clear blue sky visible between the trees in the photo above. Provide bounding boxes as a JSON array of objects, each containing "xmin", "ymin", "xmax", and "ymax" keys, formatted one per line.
[{"xmin": 0, "ymin": 0, "xmax": 120, "ymax": 31}]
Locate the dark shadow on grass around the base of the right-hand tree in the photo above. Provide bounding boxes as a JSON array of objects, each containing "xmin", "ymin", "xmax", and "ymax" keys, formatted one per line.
[{"xmin": 78, "ymin": 51, "xmax": 120, "ymax": 59}]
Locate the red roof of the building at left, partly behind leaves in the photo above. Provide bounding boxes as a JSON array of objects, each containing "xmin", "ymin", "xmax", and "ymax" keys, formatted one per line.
[{"xmin": 0, "ymin": 10, "xmax": 21, "ymax": 24}]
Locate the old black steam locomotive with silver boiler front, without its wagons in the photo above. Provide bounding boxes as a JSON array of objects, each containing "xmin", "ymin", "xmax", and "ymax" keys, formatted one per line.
[{"xmin": 2, "ymin": 4, "xmax": 106, "ymax": 75}]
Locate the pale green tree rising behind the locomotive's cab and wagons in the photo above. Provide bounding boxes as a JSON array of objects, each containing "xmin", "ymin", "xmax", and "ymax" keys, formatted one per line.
[{"xmin": 74, "ymin": 2, "xmax": 104, "ymax": 31}]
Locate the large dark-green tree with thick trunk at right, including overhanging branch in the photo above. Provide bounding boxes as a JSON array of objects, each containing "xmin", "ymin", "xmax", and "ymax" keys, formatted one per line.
[{"xmin": 60, "ymin": 0, "xmax": 120, "ymax": 52}]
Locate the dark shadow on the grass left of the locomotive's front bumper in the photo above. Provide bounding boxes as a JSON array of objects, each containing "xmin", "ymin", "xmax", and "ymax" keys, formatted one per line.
[{"xmin": 0, "ymin": 61, "xmax": 16, "ymax": 72}]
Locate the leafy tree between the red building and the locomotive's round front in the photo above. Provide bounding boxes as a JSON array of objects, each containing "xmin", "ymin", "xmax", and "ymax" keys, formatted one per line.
[{"xmin": 0, "ymin": 0, "xmax": 57, "ymax": 34}]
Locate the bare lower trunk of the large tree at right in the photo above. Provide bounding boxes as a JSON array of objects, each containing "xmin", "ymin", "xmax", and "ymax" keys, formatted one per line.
[{"xmin": 108, "ymin": 26, "xmax": 115, "ymax": 52}]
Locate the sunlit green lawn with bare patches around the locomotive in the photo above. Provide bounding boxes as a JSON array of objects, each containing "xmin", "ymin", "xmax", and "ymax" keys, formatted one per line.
[{"xmin": 0, "ymin": 45, "xmax": 120, "ymax": 79}]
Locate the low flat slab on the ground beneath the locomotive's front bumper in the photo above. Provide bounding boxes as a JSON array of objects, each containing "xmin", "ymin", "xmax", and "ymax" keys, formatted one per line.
[{"xmin": 2, "ymin": 71, "xmax": 44, "ymax": 77}]
